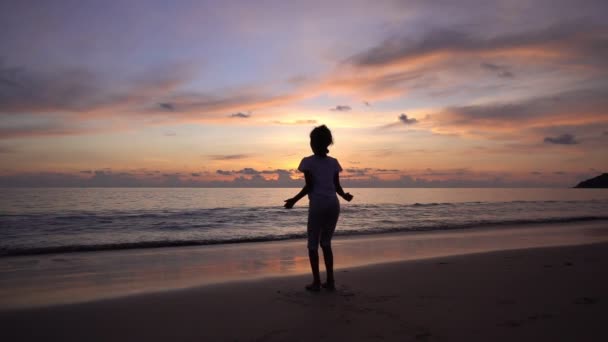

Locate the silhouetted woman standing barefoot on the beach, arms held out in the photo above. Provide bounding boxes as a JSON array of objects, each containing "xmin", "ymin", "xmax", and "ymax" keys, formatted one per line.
[{"xmin": 285, "ymin": 125, "xmax": 353, "ymax": 292}]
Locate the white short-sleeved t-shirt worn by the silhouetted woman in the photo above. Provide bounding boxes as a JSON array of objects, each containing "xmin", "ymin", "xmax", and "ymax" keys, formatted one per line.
[{"xmin": 298, "ymin": 154, "xmax": 342, "ymax": 199}]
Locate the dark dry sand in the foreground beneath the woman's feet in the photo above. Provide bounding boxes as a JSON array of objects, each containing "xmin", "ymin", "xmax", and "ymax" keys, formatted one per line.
[{"xmin": 0, "ymin": 222, "xmax": 608, "ymax": 341}]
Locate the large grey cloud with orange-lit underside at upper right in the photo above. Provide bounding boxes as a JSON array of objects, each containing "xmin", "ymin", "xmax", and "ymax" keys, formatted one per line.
[{"xmin": 322, "ymin": 20, "xmax": 608, "ymax": 101}]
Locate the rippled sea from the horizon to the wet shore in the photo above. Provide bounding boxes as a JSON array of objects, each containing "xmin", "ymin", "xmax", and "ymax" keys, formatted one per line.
[{"xmin": 0, "ymin": 188, "xmax": 608, "ymax": 257}]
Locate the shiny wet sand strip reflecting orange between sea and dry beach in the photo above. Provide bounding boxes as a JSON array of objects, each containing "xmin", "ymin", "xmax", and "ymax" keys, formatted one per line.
[{"xmin": 0, "ymin": 222, "xmax": 608, "ymax": 309}]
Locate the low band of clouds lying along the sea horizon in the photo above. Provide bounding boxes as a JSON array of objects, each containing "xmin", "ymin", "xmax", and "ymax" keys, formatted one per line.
[{"xmin": 0, "ymin": 168, "xmax": 588, "ymax": 188}]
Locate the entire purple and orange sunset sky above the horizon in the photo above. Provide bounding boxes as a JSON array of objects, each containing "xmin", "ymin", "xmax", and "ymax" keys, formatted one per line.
[{"xmin": 0, "ymin": 0, "xmax": 608, "ymax": 187}]
